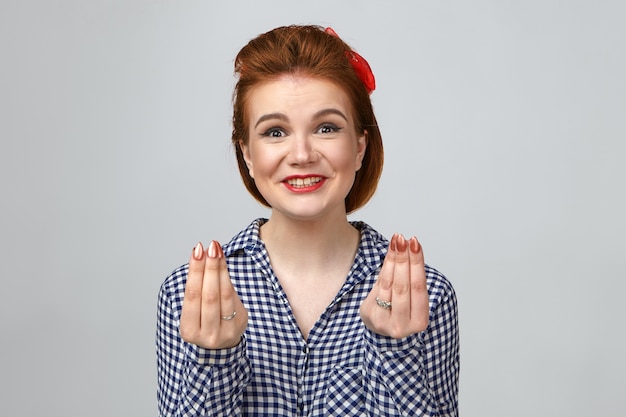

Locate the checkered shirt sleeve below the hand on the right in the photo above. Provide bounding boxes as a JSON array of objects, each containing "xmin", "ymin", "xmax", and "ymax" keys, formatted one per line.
[{"xmin": 364, "ymin": 278, "xmax": 459, "ymax": 417}]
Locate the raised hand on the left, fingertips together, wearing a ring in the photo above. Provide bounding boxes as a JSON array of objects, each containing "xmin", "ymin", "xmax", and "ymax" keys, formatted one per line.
[{"xmin": 180, "ymin": 240, "xmax": 248, "ymax": 349}]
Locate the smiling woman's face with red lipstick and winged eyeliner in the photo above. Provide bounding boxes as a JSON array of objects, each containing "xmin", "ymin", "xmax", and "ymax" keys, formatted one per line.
[{"xmin": 242, "ymin": 75, "xmax": 367, "ymax": 220}]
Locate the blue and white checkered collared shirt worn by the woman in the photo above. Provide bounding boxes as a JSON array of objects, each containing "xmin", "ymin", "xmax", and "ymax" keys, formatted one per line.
[{"xmin": 156, "ymin": 219, "xmax": 459, "ymax": 417}]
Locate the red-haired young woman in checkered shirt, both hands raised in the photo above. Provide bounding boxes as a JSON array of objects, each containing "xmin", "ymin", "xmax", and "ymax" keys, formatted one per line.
[{"xmin": 156, "ymin": 26, "xmax": 459, "ymax": 416}]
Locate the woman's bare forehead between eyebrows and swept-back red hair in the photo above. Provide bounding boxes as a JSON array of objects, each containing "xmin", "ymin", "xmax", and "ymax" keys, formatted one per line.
[{"xmin": 246, "ymin": 75, "xmax": 353, "ymax": 122}]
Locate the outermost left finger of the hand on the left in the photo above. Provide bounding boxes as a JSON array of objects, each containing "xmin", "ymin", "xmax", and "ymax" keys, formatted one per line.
[{"xmin": 180, "ymin": 243, "xmax": 205, "ymax": 337}]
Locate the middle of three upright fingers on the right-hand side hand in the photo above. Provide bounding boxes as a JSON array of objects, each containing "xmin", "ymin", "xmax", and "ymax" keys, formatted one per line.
[{"xmin": 391, "ymin": 235, "xmax": 411, "ymax": 318}]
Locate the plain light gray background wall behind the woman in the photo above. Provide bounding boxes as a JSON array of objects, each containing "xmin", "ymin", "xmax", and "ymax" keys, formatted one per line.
[{"xmin": 0, "ymin": 0, "xmax": 626, "ymax": 417}]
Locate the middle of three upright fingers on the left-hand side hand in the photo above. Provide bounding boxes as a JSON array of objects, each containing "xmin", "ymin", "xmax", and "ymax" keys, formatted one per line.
[{"xmin": 200, "ymin": 240, "xmax": 222, "ymax": 333}]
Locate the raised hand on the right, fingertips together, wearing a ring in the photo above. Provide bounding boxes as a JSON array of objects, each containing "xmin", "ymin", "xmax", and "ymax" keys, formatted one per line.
[{"xmin": 360, "ymin": 233, "xmax": 429, "ymax": 339}]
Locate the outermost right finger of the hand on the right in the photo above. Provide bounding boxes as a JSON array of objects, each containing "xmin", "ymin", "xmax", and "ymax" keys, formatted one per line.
[{"xmin": 409, "ymin": 237, "xmax": 429, "ymax": 329}]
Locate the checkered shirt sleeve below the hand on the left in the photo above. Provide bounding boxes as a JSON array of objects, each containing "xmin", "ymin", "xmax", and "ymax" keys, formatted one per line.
[{"xmin": 156, "ymin": 278, "xmax": 250, "ymax": 417}]
